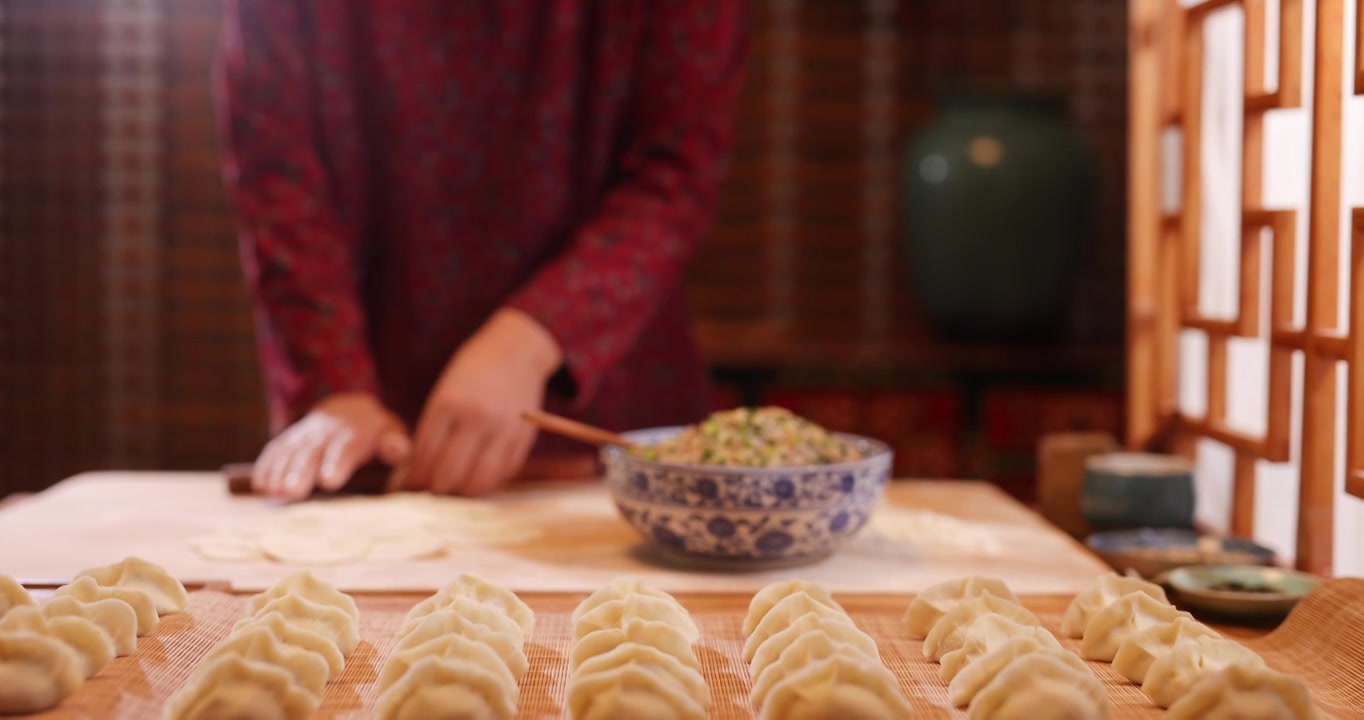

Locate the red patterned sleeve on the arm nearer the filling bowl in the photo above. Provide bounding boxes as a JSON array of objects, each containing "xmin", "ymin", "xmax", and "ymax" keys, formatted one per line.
[{"xmin": 507, "ymin": 0, "xmax": 747, "ymax": 406}]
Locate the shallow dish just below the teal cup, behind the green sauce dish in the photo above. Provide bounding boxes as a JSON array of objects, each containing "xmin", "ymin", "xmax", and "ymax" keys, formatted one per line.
[{"xmin": 1084, "ymin": 528, "xmax": 1274, "ymax": 578}]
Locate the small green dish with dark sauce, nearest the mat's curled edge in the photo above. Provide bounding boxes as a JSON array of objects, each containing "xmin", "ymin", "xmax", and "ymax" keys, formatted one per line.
[{"xmin": 1163, "ymin": 565, "xmax": 1322, "ymax": 618}]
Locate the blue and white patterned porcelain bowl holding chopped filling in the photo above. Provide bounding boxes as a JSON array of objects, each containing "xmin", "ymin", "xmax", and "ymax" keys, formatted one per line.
[{"xmin": 602, "ymin": 428, "xmax": 893, "ymax": 565}]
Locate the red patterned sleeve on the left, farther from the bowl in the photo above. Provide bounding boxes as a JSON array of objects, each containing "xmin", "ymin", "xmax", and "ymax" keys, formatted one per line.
[{"xmin": 217, "ymin": 0, "xmax": 376, "ymax": 431}]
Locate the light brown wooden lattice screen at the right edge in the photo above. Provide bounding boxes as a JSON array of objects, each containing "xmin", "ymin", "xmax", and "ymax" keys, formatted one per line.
[{"xmin": 1128, "ymin": 0, "xmax": 1364, "ymax": 574}]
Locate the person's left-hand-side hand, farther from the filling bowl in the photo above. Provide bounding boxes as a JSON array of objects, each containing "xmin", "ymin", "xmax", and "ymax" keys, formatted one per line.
[{"xmin": 251, "ymin": 393, "xmax": 412, "ymax": 500}]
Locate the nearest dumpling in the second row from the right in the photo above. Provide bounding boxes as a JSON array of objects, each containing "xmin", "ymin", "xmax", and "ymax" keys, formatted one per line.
[{"xmin": 966, "ymin": 650, "xmax": 1113, "ymax": 720}]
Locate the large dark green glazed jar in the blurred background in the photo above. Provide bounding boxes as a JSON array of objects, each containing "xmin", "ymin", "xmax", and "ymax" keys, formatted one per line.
[{"xmin": 902, "ymin": 94, "xmax": 1097, "ymax": 342}]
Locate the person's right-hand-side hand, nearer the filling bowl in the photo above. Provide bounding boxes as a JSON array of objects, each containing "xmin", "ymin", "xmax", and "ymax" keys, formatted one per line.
[{"xmin": 406, "ymin": 310, "xmax": 562, "ymax": 495}]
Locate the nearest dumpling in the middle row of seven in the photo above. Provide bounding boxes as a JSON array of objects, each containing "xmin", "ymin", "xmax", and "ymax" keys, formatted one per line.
[{"xmin": 567, "ymin": 663, "xmax": 705, "ymax": 720}]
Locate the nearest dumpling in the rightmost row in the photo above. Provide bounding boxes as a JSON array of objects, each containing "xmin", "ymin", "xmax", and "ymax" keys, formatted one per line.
[{"xmin": 1165, "ymin": 664, "xmax": 1316, "ymax": 720}]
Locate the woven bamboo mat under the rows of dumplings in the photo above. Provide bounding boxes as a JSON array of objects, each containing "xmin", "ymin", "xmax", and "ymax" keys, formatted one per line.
[{"xmin": 34, "ymin": 578, "xmax": 1364, "ymax": 720}]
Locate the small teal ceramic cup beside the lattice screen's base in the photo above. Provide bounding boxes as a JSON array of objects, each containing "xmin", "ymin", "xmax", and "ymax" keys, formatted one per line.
[{"xmin": 1080, "ymin": 453, "xmax": 1194, "ymax": 532}]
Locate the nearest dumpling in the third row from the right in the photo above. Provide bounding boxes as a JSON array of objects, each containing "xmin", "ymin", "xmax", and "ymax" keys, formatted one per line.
[{"xmin": 758, "ymin": 655, "xmax": 914, "ymax": 720}]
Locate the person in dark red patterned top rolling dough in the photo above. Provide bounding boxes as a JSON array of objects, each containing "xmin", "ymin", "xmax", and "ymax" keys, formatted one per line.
[{"xmin": 216, "ymin": 0, "xmax": 749, "ymax": 499}]
